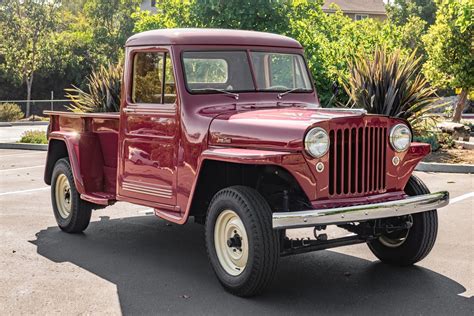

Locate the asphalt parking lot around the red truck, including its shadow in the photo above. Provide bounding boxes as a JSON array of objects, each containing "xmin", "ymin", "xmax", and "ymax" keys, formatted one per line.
[{"xmin": 0, "ymin": 150, "xmax": 474, "ymax": 315}]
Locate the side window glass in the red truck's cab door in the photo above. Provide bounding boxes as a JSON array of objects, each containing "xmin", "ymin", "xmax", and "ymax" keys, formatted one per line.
[{"xmin": 131, "ymin": 52, "xmax": 176, "ymax": 104}]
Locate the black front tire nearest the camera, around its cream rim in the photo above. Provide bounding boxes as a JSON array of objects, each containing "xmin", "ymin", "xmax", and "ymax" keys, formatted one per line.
[{"xmin": 205, "ymin": 186, "xmax": 280, "ymax": 297}]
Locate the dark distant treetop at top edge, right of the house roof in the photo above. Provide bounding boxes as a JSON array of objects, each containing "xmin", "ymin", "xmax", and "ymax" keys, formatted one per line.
[{"xmin": 387, "ymin": 0, "xmax": 436, "ymax": 25}]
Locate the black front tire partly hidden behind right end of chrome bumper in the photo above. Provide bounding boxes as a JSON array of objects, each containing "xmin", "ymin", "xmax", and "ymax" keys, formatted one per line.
[{"xmin": 368, "ymin": 175, "xmax": 438, "ymax": 266}]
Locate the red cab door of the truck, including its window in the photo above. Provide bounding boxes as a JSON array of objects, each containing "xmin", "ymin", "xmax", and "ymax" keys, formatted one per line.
[{"xmin": 118, "ymin": 49, "xmax": 179, "ymax": 207}]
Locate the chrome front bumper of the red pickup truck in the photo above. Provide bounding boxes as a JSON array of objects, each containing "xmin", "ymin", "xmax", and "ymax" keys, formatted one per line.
[{"xmin": 273, "ymin": 191, "xmax": 449, "ymax": 229}]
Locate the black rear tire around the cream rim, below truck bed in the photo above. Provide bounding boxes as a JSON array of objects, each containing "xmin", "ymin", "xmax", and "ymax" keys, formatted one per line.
[{"xmin": 51, "ymin": 158, "xmax": 93, "ymax": 233}]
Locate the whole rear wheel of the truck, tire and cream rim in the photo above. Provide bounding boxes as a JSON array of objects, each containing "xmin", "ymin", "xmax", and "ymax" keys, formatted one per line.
[{"xmin": 51, "ymin": 158, "xmax": 92, "ymax": 233}]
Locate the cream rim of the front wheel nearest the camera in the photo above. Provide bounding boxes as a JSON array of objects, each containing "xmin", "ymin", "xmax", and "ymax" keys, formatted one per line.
[{"xmin": 214, "ymin": 210, "xmax": 249, "ymax": 276}]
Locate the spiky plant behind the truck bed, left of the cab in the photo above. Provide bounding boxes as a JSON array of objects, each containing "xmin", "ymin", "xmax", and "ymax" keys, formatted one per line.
[{"xmin": 65, "ymin": 63, "xmax": 123, "ymax": 113}]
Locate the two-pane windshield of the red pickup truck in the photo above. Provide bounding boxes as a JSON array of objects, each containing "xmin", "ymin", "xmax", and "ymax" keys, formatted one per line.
[{"xmin": 183, "ymin": 51, "xmax": 312, "ymax": 93}]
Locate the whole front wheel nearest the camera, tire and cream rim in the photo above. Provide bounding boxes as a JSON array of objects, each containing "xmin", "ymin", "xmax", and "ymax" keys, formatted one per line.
[{"xmin": 206, "ymin": 186, "xmax": 280, "ymax": 297}]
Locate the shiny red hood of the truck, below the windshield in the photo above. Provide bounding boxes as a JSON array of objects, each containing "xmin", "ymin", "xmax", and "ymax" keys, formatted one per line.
[{"xmin": 209, "ymin": 107, "xmax": 365, "ymax": 151}]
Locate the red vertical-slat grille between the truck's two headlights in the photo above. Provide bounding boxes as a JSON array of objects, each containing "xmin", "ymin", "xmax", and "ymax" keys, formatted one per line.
[{"xmin": 329, "ymin": 126, "xmax": 387, "ymax": 196}]
